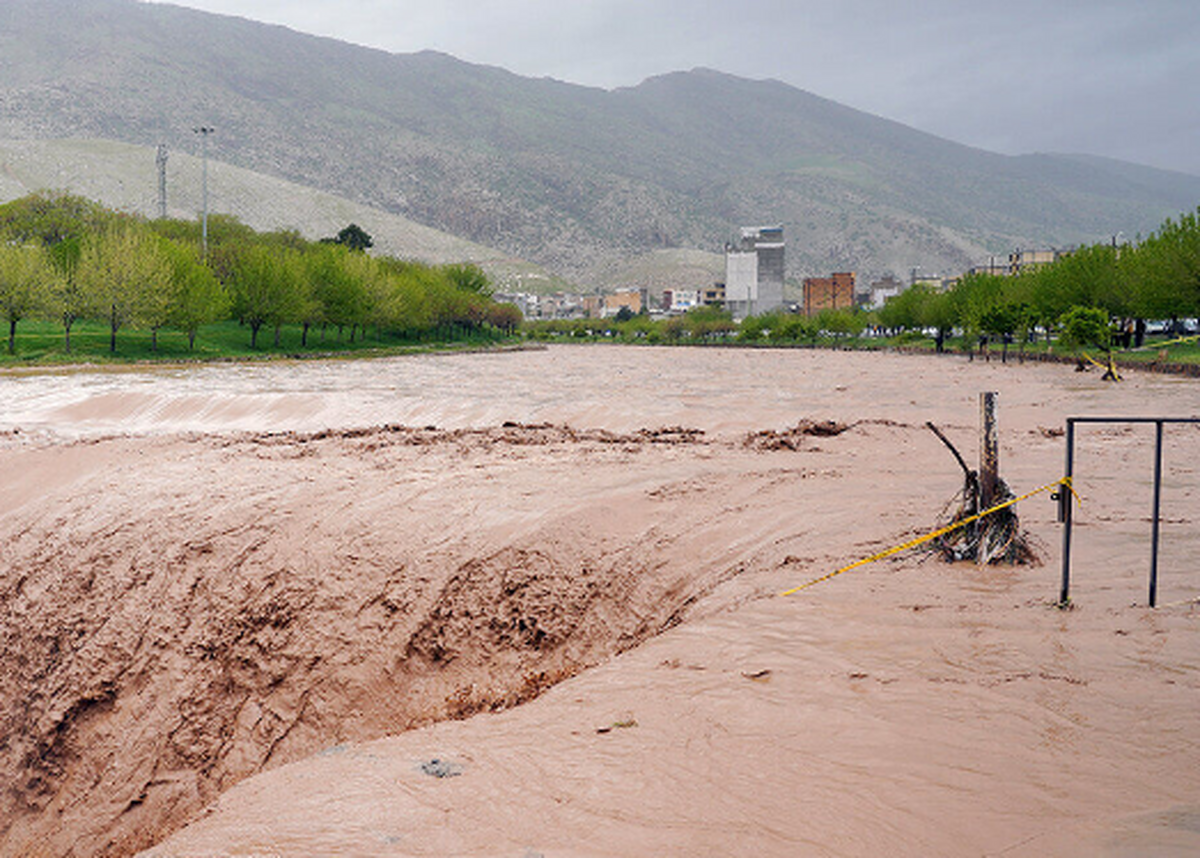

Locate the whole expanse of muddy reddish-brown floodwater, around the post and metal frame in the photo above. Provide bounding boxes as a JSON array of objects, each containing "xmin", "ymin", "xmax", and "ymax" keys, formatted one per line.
[{"xmin": 0, "ymin": 346, "xmax": 1200, "ymax": 858}]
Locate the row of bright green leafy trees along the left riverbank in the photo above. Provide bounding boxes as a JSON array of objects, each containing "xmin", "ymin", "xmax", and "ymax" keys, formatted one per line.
[{"xmin": 0, "ymin": 194, "xmax": 521, "ymax": 353}]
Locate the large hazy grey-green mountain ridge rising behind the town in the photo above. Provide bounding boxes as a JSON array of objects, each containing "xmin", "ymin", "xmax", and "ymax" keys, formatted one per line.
[{"xmin": 0, "ymin": 0, "xmax": 1200, "ymax": 286}]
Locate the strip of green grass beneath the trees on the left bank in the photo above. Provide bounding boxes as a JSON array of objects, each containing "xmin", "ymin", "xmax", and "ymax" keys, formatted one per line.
[{"xmin": 0, "ymin": 322, "xmax": 506, "ymax": 368}]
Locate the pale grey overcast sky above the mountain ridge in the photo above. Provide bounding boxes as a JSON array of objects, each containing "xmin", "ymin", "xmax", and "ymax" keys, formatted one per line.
[{"xmin": 150, "ymin": 0, "xmax": 1200, "ymax": 175}]
